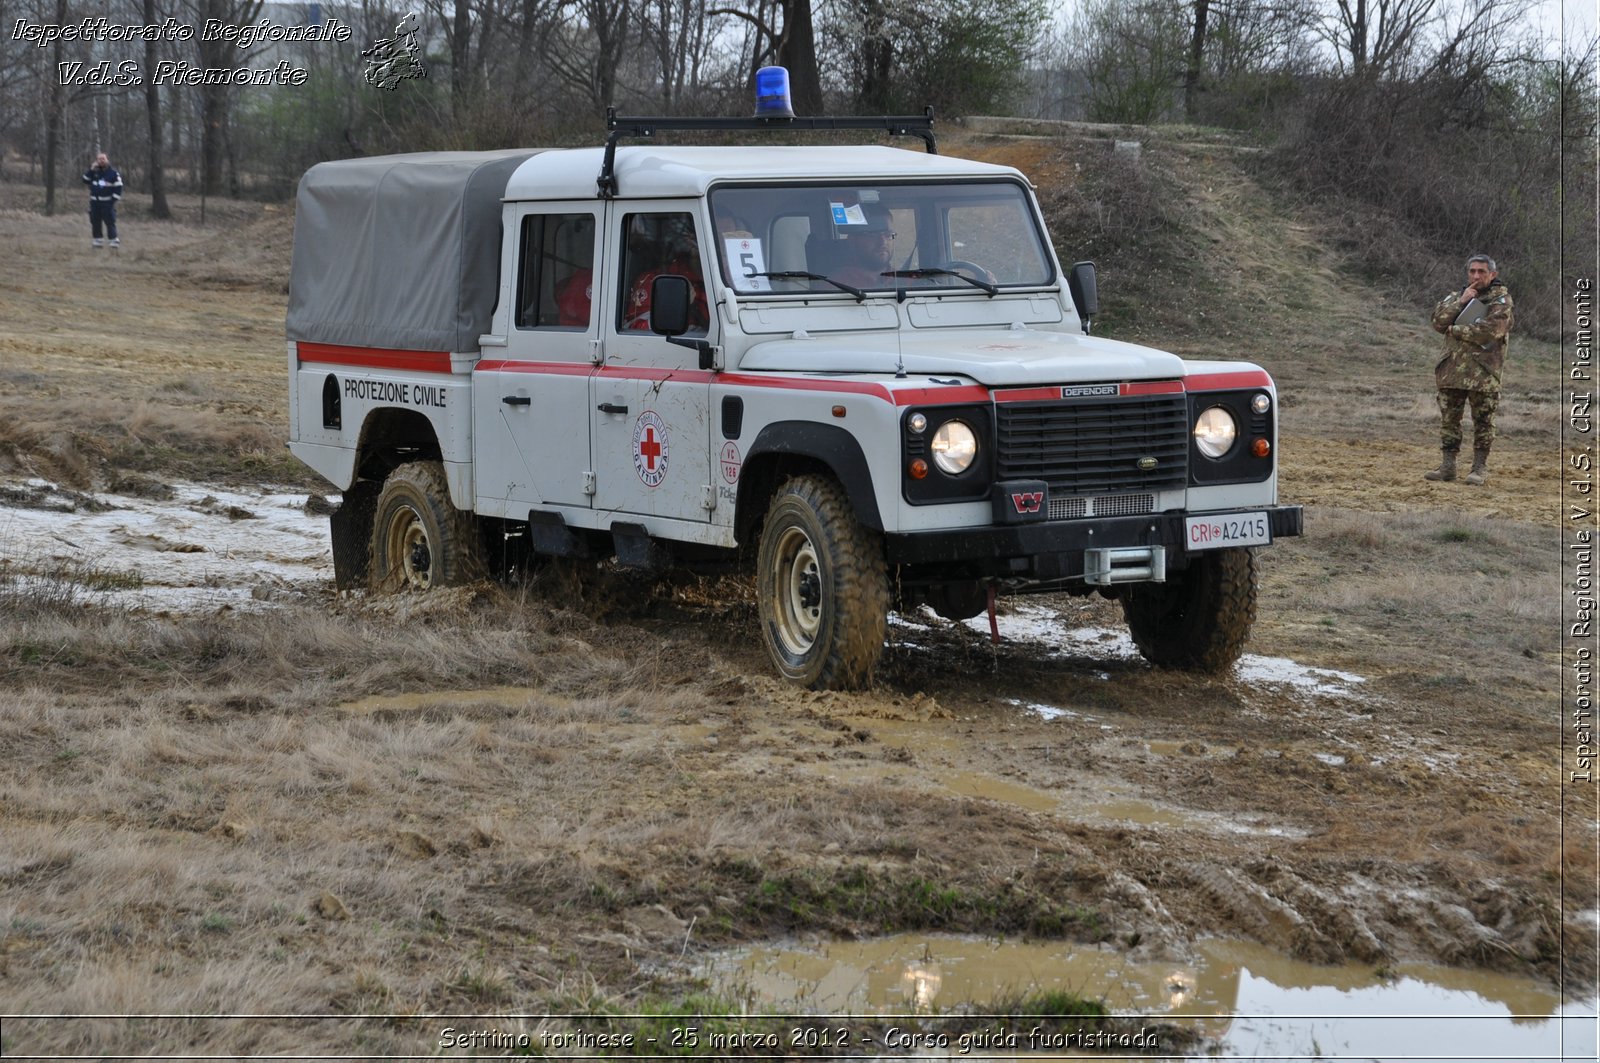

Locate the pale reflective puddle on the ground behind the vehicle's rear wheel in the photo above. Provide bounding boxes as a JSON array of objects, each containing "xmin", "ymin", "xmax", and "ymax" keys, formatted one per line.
[{"xmin": 0, "ymin": 480, "xmax": 333, "ymax": 613}]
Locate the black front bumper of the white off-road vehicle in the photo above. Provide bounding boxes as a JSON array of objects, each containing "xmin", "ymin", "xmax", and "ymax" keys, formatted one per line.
[{"xmin": 883, "ymin": 506, "xmax": 1304, "ymax": 580}]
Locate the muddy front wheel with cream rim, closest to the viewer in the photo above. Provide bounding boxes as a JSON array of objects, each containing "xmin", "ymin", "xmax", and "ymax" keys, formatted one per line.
[{"xmin": 755, "ymin": 475, "xmax": 890, "ymax": 690}]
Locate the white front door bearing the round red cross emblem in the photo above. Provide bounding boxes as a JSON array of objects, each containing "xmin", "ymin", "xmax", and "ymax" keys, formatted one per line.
[{"xmin": 589, "ymin": 200, "xmax": 717, "ymax": 522}]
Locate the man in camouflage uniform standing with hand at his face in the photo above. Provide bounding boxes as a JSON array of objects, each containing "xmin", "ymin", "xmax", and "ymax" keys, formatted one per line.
[{"xmin": 1422, "ymin": 255, "xmax": 1512, "ymax": 485}]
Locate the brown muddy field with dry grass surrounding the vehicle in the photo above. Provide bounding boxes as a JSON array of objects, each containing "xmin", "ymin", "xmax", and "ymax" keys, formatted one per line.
[{"xmin": 0, "ymin": 139, "xmax": 1595, "ymax": 1050}]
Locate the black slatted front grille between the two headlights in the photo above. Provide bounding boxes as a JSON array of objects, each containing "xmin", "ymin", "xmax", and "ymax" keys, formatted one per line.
[{"xmin": 995, "ymin": 394, "xmax": 1189, "ymax": 496}]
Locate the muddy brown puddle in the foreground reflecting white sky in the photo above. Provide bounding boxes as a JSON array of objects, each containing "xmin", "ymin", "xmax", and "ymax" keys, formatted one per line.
[{"xmin": 709, "ymin": 935, "xmax": 1600, "ymax": 1063}]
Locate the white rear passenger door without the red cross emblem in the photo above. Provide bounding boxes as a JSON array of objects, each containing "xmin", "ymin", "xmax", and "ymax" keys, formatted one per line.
[{"xmin": 474, "ymin": 203, "xmax": 600, "ymax": 515}]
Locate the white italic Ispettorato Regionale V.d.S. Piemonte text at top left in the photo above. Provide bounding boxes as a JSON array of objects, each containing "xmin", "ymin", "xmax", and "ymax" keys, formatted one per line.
[{"xmin": 11, "ymin": 16, "xmax": 352, "ymax": 86}]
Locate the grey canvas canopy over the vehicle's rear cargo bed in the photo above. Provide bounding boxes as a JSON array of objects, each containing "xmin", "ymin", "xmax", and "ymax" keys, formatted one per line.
[{"xmin": 286, "ymin": 149, "xmax": 538, "ymax": 352}]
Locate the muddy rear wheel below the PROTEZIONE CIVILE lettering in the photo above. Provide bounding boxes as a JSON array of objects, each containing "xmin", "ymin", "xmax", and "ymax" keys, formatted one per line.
[{"xmin": 370, "ymin": 461, "xmax": 485, "ymax": 594}]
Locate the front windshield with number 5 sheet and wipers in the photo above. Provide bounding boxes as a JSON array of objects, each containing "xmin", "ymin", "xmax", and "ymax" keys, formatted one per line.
[{"xmin": 710, "ymin": 179, "xmax": 1054, "ymax": 295}]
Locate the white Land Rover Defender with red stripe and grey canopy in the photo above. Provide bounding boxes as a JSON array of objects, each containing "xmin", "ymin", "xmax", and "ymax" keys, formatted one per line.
[{"xmin": 288, "ymin": 91, "xmax": 1301, "ymax": 688}]
